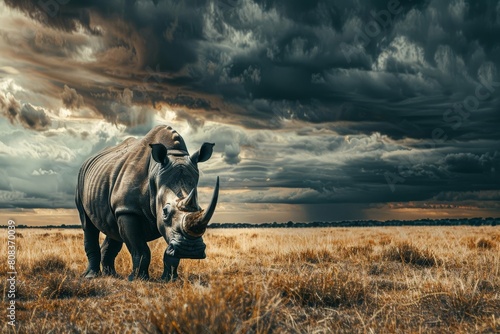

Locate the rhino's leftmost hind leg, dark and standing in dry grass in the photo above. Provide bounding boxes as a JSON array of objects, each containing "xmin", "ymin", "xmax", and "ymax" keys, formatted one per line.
[{"xmin": 81, "ymin": 213, "xmax": 101, "ymax": 279}]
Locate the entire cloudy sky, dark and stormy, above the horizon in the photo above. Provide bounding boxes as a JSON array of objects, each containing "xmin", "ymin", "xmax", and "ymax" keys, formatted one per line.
[{"xmin": 0, "ymin": 0, "xmax": 500, "ymax": 224}]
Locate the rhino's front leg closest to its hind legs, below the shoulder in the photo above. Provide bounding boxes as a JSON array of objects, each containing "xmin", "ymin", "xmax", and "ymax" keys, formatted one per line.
[{"xmin": 118, "ymin": 216, "xmax": 151, "ymax": 281}]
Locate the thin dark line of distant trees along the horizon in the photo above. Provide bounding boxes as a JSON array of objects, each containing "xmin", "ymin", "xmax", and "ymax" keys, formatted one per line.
[{"xmin": 0, "ymin": 217, "xmax": 500, "ymax": 229}]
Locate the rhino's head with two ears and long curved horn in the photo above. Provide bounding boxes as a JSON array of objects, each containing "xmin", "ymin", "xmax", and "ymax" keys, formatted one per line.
[{"xmin": 150, "ymin": 143, "xmax": 219, "ymax": 259}]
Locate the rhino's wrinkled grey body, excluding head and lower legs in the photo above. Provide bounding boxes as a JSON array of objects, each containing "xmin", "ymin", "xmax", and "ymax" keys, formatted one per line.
[{"xmin": 77, "ymin": 126, "xmax": 187, "ymax": 240}]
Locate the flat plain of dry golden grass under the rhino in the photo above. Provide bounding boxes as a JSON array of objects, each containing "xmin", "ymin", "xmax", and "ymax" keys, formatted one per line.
[{"xmin": 0, "ymin": 226, "xmax": 500, "ymax": 333}]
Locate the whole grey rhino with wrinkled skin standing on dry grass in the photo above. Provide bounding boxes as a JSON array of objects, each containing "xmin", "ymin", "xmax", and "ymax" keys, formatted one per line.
[{"xmin": 75, "ymin": 126, "xmax": 219, "ymax": 281}]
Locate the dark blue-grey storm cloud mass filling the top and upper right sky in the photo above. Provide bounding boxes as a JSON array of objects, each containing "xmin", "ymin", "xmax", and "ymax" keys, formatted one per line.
[{"xmin": 7, "ymin": 0, "xmax": 500, "ymax": 136}]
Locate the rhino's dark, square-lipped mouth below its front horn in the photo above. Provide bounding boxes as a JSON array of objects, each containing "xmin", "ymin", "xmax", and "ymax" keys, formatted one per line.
[{"xmin": 165, "ymin": 228, "xmax": 207, "ymax": 259}]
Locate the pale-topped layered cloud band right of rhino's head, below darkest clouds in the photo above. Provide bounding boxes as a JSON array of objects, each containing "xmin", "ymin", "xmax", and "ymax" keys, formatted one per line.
[{"xmin": 199, "ymin": 122, "xmax": 500, "ymax": 206}]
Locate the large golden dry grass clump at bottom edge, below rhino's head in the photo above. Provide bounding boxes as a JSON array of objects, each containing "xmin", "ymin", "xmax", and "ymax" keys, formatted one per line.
[{"xmin": 149, "ymin": 277, "xmax": 282, "ymax": 334}]
